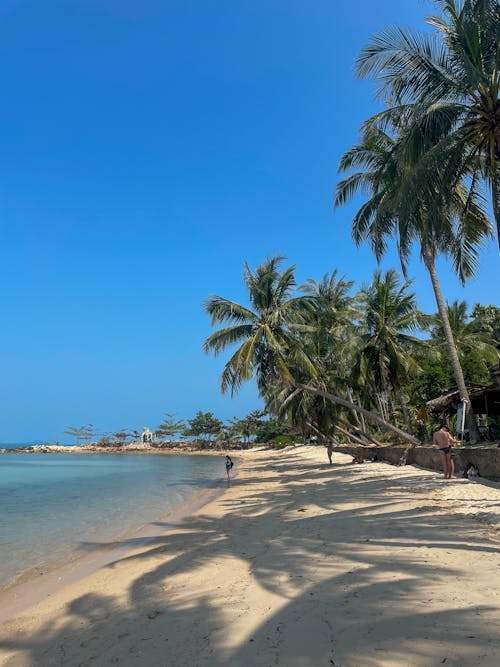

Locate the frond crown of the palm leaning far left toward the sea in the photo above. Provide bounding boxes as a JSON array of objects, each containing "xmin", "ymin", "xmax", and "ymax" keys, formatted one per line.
[{"xmin": 203, "ymin": 256, "xmax": 310, "ymax": 394}]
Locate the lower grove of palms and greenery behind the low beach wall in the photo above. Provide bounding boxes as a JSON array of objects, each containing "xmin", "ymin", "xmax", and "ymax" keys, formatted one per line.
[{"xmin": 204, "ymin": 257, "xmax": 500, "ymax": 441}]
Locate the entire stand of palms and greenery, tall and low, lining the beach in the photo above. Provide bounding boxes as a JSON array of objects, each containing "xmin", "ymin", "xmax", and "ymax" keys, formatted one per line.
[{"xmin": 204, "ymin": 0, "xmax": 500, "ymax": 443}]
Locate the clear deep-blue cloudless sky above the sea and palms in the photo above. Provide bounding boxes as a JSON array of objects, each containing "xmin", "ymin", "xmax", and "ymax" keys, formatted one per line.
[{"xmin": 0, "ymin": 0, "xmax": 500, "ymax": 442}]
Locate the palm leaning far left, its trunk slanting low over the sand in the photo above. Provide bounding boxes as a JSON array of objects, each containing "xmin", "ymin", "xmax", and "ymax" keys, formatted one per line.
[{"xmin": 203, "ymin": 257, "xmax": 418, "ymax": 444}]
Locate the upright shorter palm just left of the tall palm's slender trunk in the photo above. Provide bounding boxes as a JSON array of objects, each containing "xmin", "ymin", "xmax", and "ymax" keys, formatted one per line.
[{"xmin": 354, "ymin": 269, "xmax": 423, "ymax": 433}]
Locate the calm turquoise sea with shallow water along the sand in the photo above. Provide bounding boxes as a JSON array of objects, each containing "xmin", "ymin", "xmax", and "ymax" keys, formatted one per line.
[{"xmin": 0, "ymin": 453, "xmax": 225, "ymax": 586}]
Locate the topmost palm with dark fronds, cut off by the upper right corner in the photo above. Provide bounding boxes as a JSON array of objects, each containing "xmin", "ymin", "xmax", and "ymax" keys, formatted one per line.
[{"xmin": 357, "ymin": 0, "xmax": 500, "ymax": 244}]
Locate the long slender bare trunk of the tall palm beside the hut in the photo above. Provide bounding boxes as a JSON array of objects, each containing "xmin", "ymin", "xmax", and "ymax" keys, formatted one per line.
[{"xmin": 422, "ymin": 246, "xmax": 479, "ymax": 442}]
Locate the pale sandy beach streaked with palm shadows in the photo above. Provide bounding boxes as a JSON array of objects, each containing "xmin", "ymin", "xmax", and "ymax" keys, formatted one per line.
[{"xmin": 0, "ymin": 447, "xmax": 500, "ymax": 667}]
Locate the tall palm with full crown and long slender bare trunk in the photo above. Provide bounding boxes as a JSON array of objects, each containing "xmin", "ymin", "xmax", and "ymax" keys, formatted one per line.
[{"xmin": 335, "ymin": 119, "xmax": 492, "ymax": 440}]
